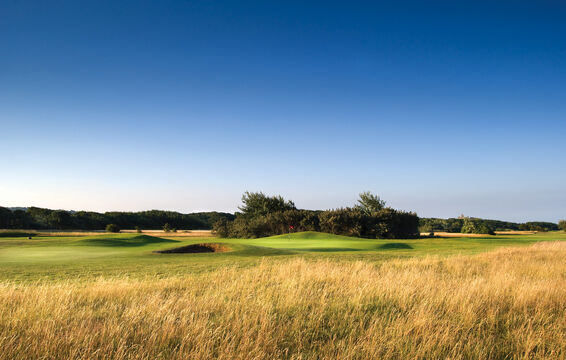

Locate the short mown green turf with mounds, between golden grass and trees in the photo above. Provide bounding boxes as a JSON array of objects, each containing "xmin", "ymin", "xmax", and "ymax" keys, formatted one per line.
[{"xmin": 0, "ymin": 232, "xmax": 566, "ymax": 282}]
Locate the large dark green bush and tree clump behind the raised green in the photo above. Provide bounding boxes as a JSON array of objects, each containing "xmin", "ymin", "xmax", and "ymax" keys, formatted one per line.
[{"xmin": 214, "ymin": 192, "xmax": 419, "ymax": 238}]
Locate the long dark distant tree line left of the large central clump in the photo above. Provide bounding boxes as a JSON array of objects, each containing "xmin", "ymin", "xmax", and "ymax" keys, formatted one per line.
[{"xmin": 0, "ymin": 207, "xmax": 234, "ymax": 230}]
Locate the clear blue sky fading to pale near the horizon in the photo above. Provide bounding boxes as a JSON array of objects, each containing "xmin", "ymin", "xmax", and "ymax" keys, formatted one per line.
[{"xmin": 0, "ymin": 0, "xmax": 566, "ymax": 221}]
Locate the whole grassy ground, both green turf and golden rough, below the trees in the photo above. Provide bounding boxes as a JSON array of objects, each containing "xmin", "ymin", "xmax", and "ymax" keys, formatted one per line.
[{"xmin": 0, "ymin": 232, "xmax": 566, "ymax": 359}]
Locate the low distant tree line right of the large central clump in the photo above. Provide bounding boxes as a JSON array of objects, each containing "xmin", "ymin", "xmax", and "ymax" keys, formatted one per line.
[{"xmin": 419, "ymin": 216, "xmax": 558, "ymax": 234}]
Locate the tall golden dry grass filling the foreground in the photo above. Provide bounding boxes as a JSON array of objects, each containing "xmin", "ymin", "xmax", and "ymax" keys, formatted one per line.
[{"xmin": 0, "ymin": 243, "xmax": 566, "ymax": 359}]
